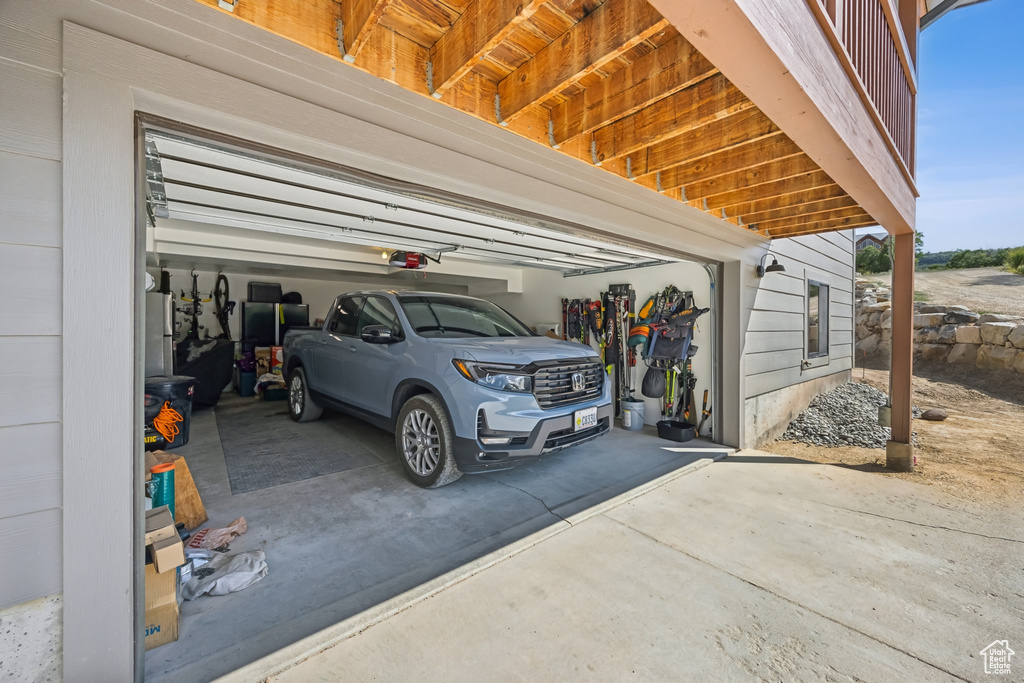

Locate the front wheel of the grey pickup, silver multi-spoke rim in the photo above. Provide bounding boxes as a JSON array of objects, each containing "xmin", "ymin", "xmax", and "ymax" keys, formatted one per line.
[{"xmin": 394, "ymin": 394, "xmax": 462, "ymax": 488}]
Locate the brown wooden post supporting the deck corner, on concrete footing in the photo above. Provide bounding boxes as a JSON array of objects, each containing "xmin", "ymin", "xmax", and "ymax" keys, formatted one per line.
[{"xmin": 886, "ymin": 232, "xmax": 915, "ymax": 472}]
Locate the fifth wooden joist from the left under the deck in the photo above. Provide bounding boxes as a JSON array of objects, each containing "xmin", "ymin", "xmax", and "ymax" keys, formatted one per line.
[{"xmin": 594, "ymin": 74, "xmax": 754, "ymax": 161}]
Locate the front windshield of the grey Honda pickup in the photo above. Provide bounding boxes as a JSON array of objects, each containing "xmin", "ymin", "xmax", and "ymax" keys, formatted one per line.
[{"xmin": 398, "ymin": 296, "xmax": 532, "ymax": 338}]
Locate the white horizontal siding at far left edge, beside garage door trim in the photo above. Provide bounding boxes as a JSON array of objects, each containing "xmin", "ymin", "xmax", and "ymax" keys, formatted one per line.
[{"xmin": 0, "ymin": 10, "xmax": 62, "ymax": 609}]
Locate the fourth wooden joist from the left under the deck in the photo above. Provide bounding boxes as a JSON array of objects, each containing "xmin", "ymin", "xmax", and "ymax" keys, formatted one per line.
[{"xmin": 551, "ymin": 36, "xmax": 718, "ymax": 144}]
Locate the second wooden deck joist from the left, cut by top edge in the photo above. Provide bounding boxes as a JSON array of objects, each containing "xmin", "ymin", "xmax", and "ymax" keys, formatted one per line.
[{"xmin": 430, "ymin": 0, "xmax": 547, "ymax": 99}]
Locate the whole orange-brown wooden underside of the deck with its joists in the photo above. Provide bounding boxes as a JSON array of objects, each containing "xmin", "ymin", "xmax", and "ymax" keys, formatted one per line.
[{"xmin": 198, "ymin": 0, "xmax": 876, "ymax": 238}]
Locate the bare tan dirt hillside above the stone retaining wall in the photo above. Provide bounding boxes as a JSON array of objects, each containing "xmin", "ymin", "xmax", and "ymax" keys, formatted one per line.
[{"xmin": 865, "ymin": 268, "xmax": 1024, "ymax": 315}]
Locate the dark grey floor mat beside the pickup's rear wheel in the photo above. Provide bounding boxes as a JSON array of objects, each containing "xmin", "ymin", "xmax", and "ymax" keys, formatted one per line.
[{"xmin": 216, "ymin": 398, "xmax": 393, "ymax": 495}]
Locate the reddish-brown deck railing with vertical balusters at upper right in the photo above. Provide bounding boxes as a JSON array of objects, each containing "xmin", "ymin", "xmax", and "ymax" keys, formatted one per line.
[{"xmin": 810, "ymin": 0, "xmax": 918, "ymax": 182}]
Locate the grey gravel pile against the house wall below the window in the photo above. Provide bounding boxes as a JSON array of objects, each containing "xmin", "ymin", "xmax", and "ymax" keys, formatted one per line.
[{"xmin": 781, "ymin": 382, "xmax": 921, "ymax": 449}]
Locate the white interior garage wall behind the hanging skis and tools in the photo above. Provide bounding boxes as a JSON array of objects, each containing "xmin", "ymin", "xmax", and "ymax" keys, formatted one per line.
[{"xmin": 488, "ymin": 262, "xmax": 714, "ymax": 430}]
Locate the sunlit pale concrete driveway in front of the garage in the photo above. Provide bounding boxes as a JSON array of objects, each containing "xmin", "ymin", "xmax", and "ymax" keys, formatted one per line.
[{"xmin": 228, "ymin": 452, "xmax": 1024, "ymax": 683}]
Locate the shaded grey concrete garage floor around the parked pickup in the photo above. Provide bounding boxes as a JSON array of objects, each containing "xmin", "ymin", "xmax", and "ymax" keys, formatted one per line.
[{"xmin": 145, "ymin": 394, "xmax": 722, "ymax": 681}]
